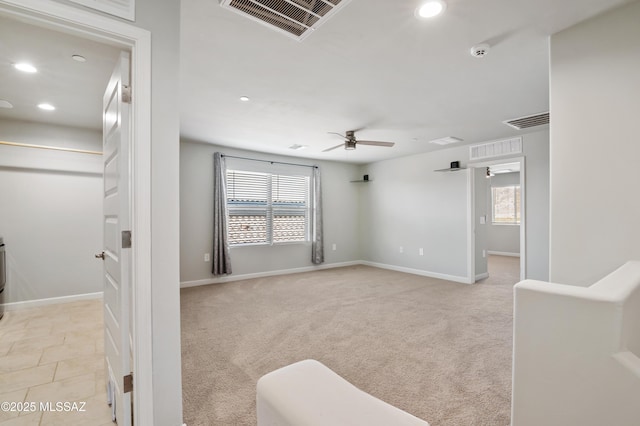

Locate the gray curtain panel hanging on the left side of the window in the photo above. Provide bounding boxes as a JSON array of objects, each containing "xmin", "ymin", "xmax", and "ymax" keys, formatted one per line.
[{"xmin": 211, "ymin": 152, "xmax": 231, "ymax": 275}]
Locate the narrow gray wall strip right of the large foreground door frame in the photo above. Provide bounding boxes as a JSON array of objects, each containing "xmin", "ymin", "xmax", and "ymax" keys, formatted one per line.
[{"xmin": 134, "ymin": 0, "xmax": 182, "ymax": 426}]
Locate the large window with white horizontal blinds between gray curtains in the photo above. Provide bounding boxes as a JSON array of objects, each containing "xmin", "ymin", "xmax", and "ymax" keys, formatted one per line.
[{"xmin": 227, "ymin": 170, "xmax": 310, "ymax": 246}]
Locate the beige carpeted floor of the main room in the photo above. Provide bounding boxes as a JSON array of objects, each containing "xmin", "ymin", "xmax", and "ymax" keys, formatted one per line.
[{"xmin": 181, "ymin": 256, "xmax": 519, "ymax": 426}]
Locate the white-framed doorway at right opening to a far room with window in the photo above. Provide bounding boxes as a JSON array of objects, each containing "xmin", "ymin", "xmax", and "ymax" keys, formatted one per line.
[{"xmin": 468, "ymin": 157, "xmax": 526, "ymax": 282}]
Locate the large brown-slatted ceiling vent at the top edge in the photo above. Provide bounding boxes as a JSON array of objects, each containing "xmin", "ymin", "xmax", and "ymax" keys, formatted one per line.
[{"xmin": 220, "ymin": 0, "xmax": 351, "ymax": 41}]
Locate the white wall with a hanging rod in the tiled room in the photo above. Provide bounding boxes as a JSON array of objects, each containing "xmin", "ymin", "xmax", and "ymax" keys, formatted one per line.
[{"xmin": 0, "ymin": 119, "xmax": 102, "ymax": 303}]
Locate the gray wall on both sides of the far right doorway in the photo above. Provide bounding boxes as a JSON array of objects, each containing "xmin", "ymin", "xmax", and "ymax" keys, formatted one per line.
[{"xmin": 360, "ymin": 130, "xmax": 549, "ymax": 280}]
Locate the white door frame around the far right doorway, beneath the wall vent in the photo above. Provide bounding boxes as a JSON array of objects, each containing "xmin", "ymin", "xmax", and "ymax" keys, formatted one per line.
[{"xmin": 467, "ymin": 156, "xmax": 527, "ymax": 283}]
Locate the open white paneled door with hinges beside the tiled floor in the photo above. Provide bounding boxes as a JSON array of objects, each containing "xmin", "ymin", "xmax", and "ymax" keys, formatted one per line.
[{"xmin": 102, "ymin": 52, "xmax": 132, "ymax": 426}]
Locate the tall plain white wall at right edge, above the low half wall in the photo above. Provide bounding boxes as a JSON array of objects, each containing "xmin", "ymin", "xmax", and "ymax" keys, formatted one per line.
[{"xmin": 550, "ymin": 2, "xmax": 640, "ymax": 285}]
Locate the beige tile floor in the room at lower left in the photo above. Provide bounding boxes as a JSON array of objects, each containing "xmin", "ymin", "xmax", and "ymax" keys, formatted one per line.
[{"xmin": 0, "ymin": 300, "xmax": 115, "ymax": 426}]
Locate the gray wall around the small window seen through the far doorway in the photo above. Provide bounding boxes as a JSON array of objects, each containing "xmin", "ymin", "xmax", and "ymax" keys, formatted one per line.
[{"xmin": 487, "ymin": 172, "xmax": 520, "ymax": 254}]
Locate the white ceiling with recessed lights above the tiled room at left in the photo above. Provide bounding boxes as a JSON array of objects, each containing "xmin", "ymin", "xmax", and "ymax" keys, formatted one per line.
[{"xmin": 0, "ymin": 16, "xmax": 118, "ymax": 131}]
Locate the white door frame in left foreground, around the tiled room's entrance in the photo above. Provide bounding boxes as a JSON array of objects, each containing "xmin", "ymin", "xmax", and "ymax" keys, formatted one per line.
[{"xmin": 0, "ymin": 0, "xmax": 155, "ymax": 425}]
